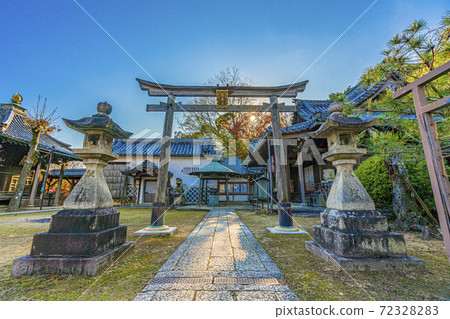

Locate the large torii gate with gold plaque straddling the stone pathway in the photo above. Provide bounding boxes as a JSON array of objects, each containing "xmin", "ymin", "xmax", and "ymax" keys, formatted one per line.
[{"xmin": 136, "ymin": 79, "xmax": 308, "ymax": 236}]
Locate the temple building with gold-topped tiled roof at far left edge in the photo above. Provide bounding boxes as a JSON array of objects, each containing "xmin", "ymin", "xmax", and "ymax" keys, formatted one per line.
[{"xmin": 0, "ymin": 94, "xmax": 81, "ymax": 207}]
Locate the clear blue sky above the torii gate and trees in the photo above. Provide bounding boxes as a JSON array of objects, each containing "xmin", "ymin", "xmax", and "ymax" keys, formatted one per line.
[{"xmin": 0, "ymin": 0, "xmax": 449, "ymax": 147}]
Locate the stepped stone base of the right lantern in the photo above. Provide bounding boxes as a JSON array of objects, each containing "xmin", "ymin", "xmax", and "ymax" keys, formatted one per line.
[{"xmin": 306, "ymin": 208, "xmax": 425, "ymax": 271}]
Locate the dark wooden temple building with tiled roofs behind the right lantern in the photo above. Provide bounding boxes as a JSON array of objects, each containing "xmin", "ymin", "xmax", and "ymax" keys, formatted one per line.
[{"xmin": 244, "ymin": 76, "xmax": 406, "ymax": 206}]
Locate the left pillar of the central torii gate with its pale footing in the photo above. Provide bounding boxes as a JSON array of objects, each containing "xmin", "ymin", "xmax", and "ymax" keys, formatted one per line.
[{"xmin": 134, "ymin": 95, "xmax": 177, "ymax": 237}]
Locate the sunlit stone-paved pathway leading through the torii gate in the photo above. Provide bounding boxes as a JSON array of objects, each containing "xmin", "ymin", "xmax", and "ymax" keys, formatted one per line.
[{"xmin": 134, "ymin": 208, "xmax": 298, "ymax": 301}]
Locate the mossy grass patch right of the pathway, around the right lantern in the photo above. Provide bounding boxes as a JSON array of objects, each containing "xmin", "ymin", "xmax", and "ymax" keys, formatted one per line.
[{"xmin": 238, "ymin": 211, "xmax": 450, "ymax": 300}]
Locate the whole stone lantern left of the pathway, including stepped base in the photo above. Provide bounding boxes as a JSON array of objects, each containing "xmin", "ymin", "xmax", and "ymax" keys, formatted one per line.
[{"xmin": 11, "ymin": 102, "xmax": 132, "ymax": 276}]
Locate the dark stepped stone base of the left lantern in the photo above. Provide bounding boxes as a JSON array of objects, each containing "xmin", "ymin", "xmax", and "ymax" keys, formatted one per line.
[{"xmin": 11, "ymin": 208, "xmax": 133, "ymax": 277}]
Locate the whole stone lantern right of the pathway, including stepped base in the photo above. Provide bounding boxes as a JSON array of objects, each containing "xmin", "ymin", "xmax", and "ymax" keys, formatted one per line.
[{"xmin": 306, "ymin": 103, "xmax": 424, "ymax": 270}]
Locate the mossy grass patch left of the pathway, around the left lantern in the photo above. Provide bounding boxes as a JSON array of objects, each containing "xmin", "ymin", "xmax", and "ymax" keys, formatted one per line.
[{"xmin": 0, "ymin": 209, "xmax": 207, "ymax": 300}]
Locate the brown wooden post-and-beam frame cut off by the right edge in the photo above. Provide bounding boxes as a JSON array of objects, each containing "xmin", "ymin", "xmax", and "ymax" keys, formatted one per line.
[{"xmin": 393, "ymin": 61, "xmax": 450, "ymax": 262}]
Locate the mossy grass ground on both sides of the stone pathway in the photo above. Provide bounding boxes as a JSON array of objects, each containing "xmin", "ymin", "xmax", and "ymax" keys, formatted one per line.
[{"xmin": 0, "ymin": 209, "xmax": 450, "ymax": 300}]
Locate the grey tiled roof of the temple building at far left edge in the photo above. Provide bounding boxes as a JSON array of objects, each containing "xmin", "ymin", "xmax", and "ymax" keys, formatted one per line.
[{"xmin": 0, "ymin": 104, "xmax": 81, "ymax": 160}]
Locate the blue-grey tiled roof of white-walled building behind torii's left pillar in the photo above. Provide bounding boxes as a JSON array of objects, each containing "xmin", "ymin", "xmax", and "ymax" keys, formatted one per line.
[{"xmin": 112, "ymin": 138, "xmax": 217, "ymax": 157}]
